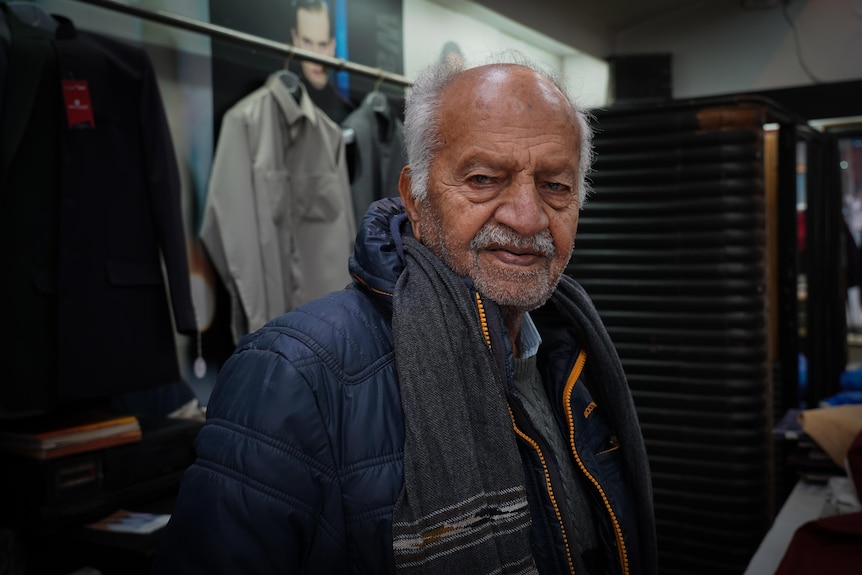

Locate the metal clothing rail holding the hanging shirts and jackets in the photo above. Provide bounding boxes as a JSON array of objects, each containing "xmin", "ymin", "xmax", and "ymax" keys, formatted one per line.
[{"xmin": 71, "ymin": 0, "xmax": 413, "ymax": 87}]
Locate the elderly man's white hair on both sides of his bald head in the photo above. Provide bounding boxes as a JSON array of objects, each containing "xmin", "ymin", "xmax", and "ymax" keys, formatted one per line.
[{"xmin": 404, "ymin": 50, "xmax": 595, "ymax": 207}]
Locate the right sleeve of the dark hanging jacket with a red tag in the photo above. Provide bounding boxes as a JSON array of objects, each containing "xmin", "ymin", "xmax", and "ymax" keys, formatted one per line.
[{"xmin": 140, "ymin": 53, "xmax": 198, "ymax": 334}]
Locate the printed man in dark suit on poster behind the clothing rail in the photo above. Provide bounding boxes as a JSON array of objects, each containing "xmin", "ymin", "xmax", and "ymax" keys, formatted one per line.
[{"xmin": 290, "ymin": 0, "xmax": 354, "ymax": 123}]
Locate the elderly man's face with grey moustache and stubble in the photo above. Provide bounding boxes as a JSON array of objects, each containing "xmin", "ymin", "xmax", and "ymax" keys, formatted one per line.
[{"xmin": 401, "ymin": 66, "xmax": 580, "ymax": 311}]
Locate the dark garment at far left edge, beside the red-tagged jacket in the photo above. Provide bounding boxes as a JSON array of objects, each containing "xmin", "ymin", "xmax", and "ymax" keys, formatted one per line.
[{"xmin": 0, "ymin": 4, "xmax": 62, "ymax": 410}]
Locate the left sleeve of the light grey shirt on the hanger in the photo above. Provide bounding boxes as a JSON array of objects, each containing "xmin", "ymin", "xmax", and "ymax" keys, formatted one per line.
[{"xmin": 200, "ymin": 110, "xmax": 264, "ymax": 343}]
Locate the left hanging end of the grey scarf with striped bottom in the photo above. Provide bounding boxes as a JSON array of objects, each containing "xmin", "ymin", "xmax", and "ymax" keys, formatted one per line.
[{"xmin": 392, "ymin": 236, "xmax": 536, "ymax": 575}]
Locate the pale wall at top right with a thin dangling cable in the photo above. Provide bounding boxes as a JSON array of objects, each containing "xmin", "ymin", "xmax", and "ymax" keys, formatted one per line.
[{"xmin": 615, "ymin": 0, "xmax": 862, "ymax": 98}]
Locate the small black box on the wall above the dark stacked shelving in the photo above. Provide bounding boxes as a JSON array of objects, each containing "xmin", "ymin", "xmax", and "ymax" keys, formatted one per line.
[{"xmin": 608, "ymin": 54, "xmax": 673, "ymax": 105}]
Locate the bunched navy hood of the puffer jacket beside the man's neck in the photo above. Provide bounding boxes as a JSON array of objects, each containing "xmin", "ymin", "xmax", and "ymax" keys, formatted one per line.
[{"xmin": 348, "ymin": 198, "xmax": 413, "ymax": 308}]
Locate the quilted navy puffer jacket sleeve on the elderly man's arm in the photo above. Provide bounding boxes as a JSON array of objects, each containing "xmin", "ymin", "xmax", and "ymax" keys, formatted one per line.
[{"xmin": 152, "ymin": 329, "xmax": 348, "ymax": 575}]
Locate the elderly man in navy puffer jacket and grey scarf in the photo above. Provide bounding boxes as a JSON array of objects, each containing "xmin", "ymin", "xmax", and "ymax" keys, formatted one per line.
[{"xmin": 154, "ymin": 54, "xmax": 656, "ymax": 575}]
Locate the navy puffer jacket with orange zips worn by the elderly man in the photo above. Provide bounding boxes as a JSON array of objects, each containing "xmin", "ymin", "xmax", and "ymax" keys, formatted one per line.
[{"xmin": 153, "ymin": 199, "xmax": 655, "ymax": 575}]
